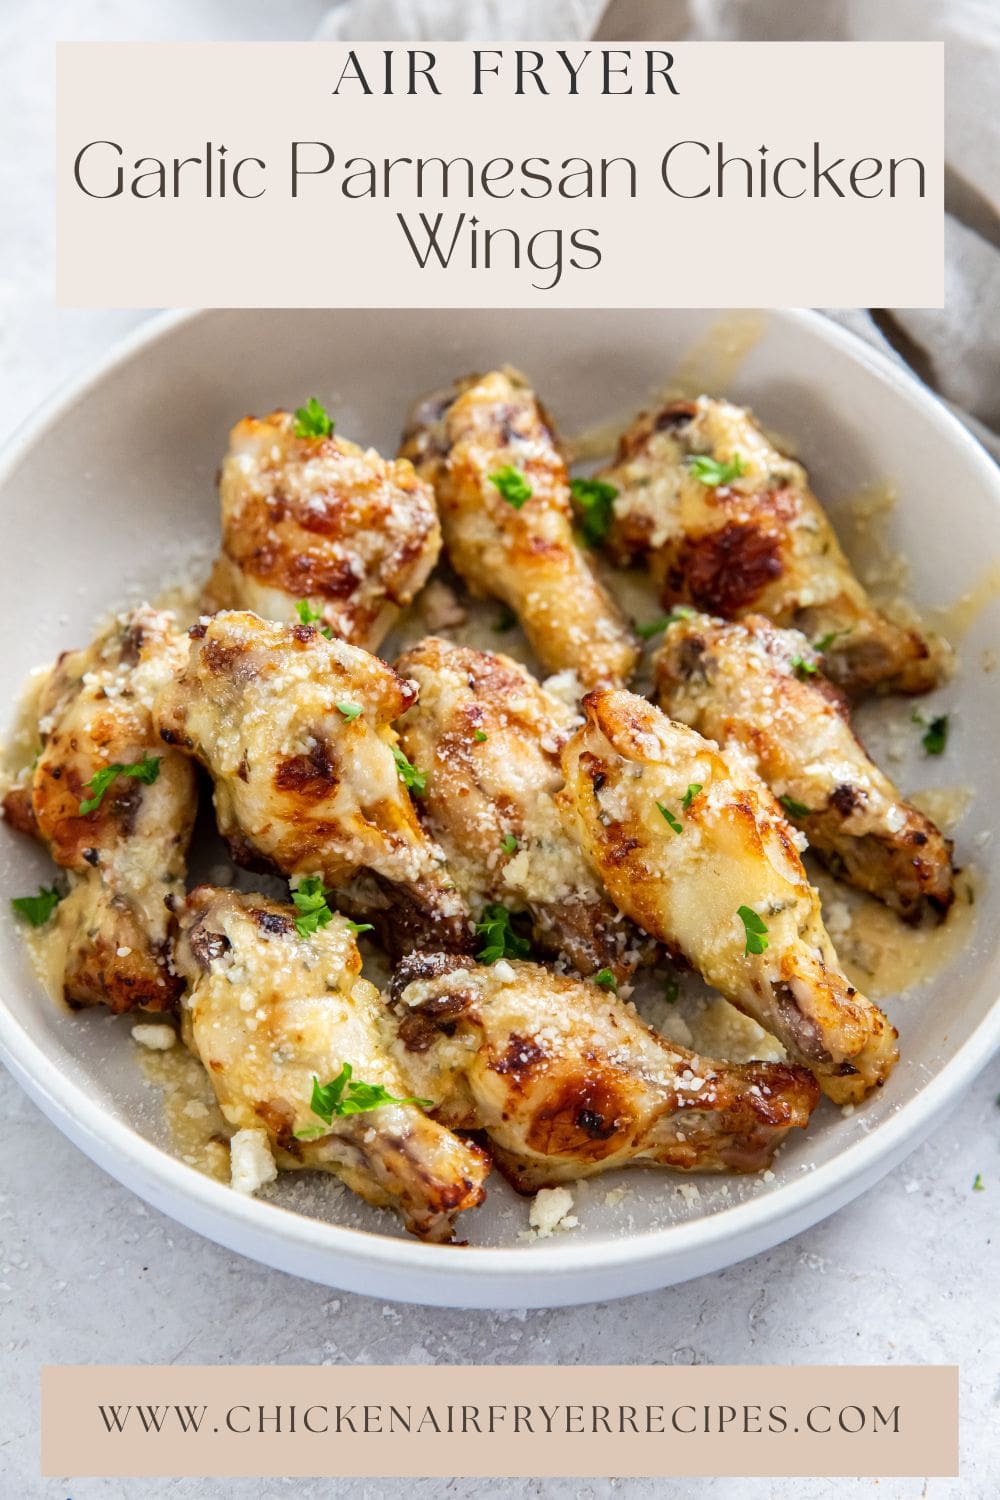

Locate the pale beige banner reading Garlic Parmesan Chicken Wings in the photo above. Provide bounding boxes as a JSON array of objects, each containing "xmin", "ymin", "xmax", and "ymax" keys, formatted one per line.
[{"xmin": 57, "ymin": 42, "xmax": 943, "ymax": 308}]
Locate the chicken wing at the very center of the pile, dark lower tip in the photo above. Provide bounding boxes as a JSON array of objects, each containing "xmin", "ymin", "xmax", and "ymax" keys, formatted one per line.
[{"xmin": 396, "ymin": 636, "xmax": 639, "ymax": 980}]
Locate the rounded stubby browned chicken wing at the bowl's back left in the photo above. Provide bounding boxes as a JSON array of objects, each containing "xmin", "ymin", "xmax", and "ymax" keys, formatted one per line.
[{"xmin": 204, "ymin": 411, "xmax": 441, "ymax": 651}]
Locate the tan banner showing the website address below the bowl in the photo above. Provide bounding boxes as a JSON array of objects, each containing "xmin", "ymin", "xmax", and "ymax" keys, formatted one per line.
[{"xmin": 42, "ymin": 1365, "xmax": 958, "ymax": 1478}]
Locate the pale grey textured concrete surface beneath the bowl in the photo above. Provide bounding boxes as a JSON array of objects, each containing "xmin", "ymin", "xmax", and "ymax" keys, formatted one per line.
[{"xmin": 0, "ymin": 0, "xmax": 1000, "ymax": 1500}]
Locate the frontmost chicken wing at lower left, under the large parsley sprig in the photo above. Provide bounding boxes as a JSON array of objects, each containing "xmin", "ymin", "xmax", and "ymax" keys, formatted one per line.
[{"xmin": 177, "ymin": 885, "xmax": 489, "ymax": 1241}]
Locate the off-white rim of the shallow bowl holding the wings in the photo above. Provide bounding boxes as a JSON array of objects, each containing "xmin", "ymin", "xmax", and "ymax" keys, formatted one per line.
[{"xmin": 0, "ymin": 308, "xmax": 1000, "ymax": 1305}]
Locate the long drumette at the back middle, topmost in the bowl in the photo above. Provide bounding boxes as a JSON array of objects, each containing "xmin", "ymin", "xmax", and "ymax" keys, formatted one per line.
[{"xmin": 402, "ymin": 371, "xmax": 637, "ymax": 687}]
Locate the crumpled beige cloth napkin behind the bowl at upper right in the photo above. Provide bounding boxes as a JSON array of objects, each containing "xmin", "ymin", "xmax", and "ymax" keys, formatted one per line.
[{"xmin": 318, "ymin": 0, "xmax": 1000, "ymax": 458}]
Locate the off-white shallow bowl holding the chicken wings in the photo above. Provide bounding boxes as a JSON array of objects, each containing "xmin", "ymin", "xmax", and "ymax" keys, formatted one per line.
[{"xmin": 0, "ymin": 311, "xmax": 1000, "ymax": 1307}]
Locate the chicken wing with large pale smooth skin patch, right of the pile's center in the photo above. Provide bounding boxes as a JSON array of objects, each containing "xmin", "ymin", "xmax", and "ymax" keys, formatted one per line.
[{"xmin": 561, "ymin": 692, "xmax": 898, "ymax": 1104}]
